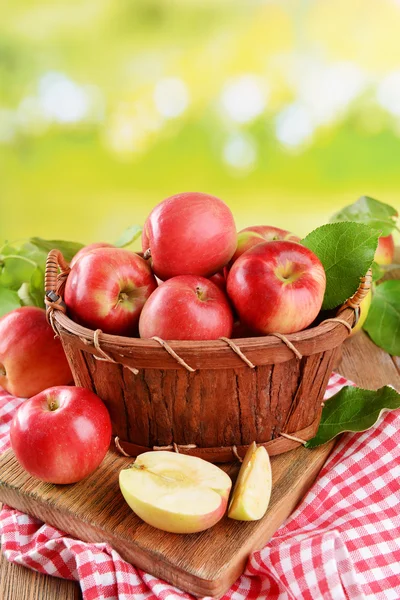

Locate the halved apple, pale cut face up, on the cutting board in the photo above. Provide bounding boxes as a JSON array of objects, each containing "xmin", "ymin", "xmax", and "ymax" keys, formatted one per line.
[{"xmin": 119, "ymin": 450, "xmax": 232, "ymax": 533}]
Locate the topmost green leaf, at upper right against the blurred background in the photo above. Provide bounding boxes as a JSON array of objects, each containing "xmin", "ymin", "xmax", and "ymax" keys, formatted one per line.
[{"xmin": 331, "ymin": 196, "xmax": 398, "ymax": 236}]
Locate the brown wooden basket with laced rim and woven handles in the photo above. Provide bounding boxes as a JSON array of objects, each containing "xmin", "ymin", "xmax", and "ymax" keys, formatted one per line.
[{"xmin": 45, "ymin": 250, "xmax": 371, "ymax": 462}]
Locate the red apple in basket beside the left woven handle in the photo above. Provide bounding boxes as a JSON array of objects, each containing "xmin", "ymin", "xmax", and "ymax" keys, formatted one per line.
[{"xmin": 64, "ymin": 248, "xmax": 157, "ymax": 336}]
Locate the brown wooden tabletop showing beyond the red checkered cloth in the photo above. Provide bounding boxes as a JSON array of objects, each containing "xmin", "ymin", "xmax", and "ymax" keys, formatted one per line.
[{"xmin": 0, "ymin": 268, "xmax": 400, "ymax": 600}]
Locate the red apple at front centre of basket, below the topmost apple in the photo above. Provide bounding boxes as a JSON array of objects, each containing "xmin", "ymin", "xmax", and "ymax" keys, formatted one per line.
[{"xmin": 139, "ymin": 275, "xmax": 233, "ymax": 340}]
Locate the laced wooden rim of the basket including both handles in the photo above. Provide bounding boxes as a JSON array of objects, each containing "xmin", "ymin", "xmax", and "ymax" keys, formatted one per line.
[{"xmin": 45, "ymin": 250, "xmax": 372, "ymax": 371}]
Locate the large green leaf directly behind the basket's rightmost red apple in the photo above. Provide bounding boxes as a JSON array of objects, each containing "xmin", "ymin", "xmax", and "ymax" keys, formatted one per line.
[{"xmin": 302, "ymin": 223, "xmax": 379, "ymax": 309}]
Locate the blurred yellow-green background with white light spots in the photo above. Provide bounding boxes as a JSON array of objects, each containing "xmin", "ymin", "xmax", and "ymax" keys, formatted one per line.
[{"xmin": 0, "ymin": 0, "xmax": 400, "ymax": 243}]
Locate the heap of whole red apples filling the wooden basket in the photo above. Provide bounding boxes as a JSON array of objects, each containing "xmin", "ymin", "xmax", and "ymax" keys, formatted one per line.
[{"xmin": 64, "ymin": 193, "xmax": 326, "ymax": 340}]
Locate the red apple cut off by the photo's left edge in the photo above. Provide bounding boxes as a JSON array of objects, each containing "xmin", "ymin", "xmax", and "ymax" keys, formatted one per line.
[{"xmin": 0, "ymin": 306, "xmax": 72, "ymax": 398}]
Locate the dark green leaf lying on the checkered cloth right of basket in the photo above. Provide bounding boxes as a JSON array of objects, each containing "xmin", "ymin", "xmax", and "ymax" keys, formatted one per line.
[{"xmin": 306, "ymin": 386, "xmax": 400, "ymax": 448}]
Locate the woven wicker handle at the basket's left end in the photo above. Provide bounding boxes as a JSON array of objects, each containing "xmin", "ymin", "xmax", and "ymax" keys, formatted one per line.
[{"xmin": 44, "ymin": 249, "xmax": 71, "ymax": 322}]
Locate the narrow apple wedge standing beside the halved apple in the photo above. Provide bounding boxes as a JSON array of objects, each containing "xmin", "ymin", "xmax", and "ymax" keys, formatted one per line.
[{"xmin": 228, "ymin": 442, "xmax": 272, "ymax": 521}]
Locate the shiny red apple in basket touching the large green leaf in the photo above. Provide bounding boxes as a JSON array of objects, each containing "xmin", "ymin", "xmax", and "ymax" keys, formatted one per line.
[{"xmin": 227, "ymin": 241, "xmax": 326, "ymax": 335}]
